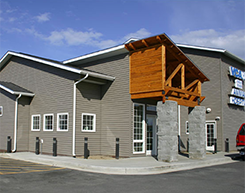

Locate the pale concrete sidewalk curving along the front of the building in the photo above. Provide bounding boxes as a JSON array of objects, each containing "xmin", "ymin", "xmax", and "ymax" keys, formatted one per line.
[{"xmin": 0, "ymin": 152, "xmax": 238, "ymax": 175}]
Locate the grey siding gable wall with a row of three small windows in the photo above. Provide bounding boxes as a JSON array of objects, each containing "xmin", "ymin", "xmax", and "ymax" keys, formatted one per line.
[{"xmin": 0, "ymin": 57, "xmax": 80, "ymax": 155}]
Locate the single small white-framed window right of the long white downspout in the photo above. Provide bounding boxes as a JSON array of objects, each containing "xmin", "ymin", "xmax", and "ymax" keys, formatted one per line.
[{"xmin": 82, "ymin": 113, "xmax": 96, "ymax": 132}]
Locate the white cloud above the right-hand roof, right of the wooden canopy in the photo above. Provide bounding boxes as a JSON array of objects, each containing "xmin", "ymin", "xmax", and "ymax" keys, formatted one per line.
[{"xmin": 171, "ymin": 29, "xmax": 245, "ymax": 59}]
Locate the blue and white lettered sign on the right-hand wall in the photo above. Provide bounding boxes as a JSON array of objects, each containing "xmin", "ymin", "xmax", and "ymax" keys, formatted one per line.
[{"xmin": 229, "ymin": 66, "xmax": 245, "ymax": 107}]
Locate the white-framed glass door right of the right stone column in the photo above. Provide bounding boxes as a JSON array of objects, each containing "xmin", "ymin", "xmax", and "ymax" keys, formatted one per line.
[{"xmin": 205, "ymin": 121, "xmax": 217, "ymax": 151}]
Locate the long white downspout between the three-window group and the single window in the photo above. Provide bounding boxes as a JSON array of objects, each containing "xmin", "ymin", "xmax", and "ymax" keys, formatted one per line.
[{"xmin": 72, "ymin": 73, "xmax": 88, "ymax": 157}]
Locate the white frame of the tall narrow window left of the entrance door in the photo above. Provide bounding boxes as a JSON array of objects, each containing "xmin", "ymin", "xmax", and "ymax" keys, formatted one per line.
[{"xmin": 133, "ymin": 103, "xmax": 146, "ymax": 154}]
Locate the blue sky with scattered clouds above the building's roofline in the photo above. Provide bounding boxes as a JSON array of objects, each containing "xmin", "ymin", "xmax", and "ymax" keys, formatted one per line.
[{"xmin": 0, "ymin": 0, "xmax": 245, "ymax": 61}]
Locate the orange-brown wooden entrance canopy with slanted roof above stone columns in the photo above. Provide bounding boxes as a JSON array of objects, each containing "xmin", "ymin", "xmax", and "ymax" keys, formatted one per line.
[{"xmin": 125, "ymin": 34, "xmax": 209, "ymax": 107}]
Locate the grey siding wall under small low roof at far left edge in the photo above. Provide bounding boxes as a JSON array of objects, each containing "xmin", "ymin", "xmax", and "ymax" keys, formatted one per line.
[{"xmin": 0, "ymin": 89, "xmax": 15, "ymax": 151}]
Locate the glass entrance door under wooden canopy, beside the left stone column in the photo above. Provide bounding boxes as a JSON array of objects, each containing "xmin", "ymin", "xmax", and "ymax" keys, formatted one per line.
[{"xmin": 146, "ymin": 115, "xmax": 157, "ymax": 155}]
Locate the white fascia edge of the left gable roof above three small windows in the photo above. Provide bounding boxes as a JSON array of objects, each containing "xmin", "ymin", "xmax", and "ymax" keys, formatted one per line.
[{"xmin": 0, "ymin": 51, "xmax": 115, "ymax": 81}]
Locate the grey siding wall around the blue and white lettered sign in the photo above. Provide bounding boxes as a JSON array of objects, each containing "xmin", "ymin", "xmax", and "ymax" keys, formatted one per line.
[{"xmin": 221, "ymin": 56, "xmax": 245, "ymax": 150}]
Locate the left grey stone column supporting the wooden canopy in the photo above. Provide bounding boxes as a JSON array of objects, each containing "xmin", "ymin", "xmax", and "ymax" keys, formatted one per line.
[{"xmin": 157, "ymin": 101, "xmax": 178, "ymax": 162}]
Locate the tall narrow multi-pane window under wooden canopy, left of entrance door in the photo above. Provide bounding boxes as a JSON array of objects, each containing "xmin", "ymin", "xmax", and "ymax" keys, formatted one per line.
[{"xmin": 133, "ymin": 103, "xmax": 145, "ymax": 153}]
